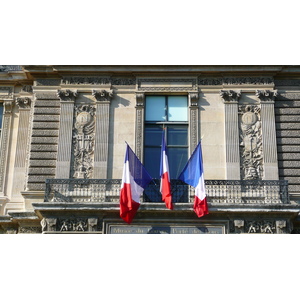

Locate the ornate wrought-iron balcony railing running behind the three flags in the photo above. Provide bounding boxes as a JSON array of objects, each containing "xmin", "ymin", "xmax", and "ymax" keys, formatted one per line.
[{"xmin": 44, "ymin": 179, "xmax": 289, "ymax": 205}]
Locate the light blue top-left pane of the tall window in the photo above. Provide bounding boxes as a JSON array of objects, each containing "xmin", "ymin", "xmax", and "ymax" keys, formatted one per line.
[{"xmin": 145, "ymin": 96, "xmax": 166, "ymax": 121}]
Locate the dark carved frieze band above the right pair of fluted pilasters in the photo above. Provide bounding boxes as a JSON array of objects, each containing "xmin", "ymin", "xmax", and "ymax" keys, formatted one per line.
[{"xmin": 198, "ymin": 77, "xmax": 274, "ymax": 85}]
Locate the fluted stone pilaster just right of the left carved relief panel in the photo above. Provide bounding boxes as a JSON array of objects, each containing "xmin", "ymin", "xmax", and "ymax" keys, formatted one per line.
[{"xmin": 92, "ymin": 90, "xmax": 113, "ymax": 179}]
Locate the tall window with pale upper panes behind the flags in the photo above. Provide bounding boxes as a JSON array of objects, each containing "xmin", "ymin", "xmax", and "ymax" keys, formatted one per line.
[{"xmin": 144, "ymin": 96, "xmax": 188, "ymax": 179}]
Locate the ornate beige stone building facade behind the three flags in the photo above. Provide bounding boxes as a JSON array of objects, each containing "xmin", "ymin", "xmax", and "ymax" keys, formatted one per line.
[{"xmin": 0, "ymin": 65, "xmax": 300, "ymax": 234}]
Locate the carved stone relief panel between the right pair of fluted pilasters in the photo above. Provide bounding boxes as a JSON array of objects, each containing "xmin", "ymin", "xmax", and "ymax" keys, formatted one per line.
[{"xmin": 239, "ymin": 105, "xmax": 263, "ymax": 180}]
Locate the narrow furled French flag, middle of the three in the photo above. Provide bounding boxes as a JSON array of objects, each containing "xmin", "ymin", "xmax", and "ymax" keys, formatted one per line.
[{"xmin": 160, "ymin": 131, "xmax": 173, "ymax": 209}]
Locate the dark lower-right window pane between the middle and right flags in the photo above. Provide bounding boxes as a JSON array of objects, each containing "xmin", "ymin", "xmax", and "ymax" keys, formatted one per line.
[{"xmin": 168, "ymin": 148, "xmax": 188, "ymax": 179}]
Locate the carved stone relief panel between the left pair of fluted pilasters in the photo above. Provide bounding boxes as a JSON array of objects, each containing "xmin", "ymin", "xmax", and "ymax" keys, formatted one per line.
[{"xmin": 71, "ymin": 105, "xmax": 95, "ymax": 178}]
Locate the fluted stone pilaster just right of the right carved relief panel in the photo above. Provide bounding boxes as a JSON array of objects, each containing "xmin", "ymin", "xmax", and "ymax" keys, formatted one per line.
[{"xmin": 256, "ymin": 90, "xmax": 279, "ymax": 180}]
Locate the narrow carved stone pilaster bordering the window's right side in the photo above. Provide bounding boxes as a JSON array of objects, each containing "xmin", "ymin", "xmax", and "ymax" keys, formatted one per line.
[{"xmin": 189, "ymin": 92, "xmax": 199, "ymax": 156}]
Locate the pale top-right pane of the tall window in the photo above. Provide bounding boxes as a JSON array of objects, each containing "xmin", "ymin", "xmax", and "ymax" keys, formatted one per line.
[{"xmin": 168, "ymin": 96, "xmax": 188, "ymax": 121}]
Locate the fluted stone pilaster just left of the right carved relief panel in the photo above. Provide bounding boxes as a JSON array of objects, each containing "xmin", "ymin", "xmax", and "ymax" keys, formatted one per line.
[{"xmin": 220, "ymin": 90, "xmax": 241, "ymax": 180}]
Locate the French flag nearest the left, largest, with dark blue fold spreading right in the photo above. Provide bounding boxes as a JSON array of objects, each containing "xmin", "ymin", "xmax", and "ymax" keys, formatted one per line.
[{"xmin": 120, "ymin": 144, "xmax": 152, "ymax": 224}]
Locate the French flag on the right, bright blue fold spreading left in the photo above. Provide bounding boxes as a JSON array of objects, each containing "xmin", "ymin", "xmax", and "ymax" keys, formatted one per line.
[{"xmin": 178, "ymin": 142, "xmax": 208, "ymax": 218}]
